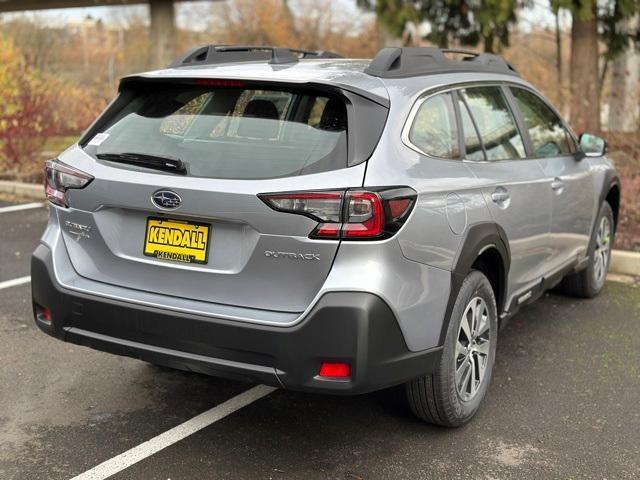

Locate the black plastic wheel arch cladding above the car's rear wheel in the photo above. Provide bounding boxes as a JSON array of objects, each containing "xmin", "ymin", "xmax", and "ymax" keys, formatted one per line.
[{"xmin": 440, "ymin": 222, "xmax": 511, "ymax": 345}]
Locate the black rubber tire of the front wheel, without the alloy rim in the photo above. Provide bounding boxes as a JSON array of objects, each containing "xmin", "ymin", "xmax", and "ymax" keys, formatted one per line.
[{"xmin": 557, "ymin": 201, "xmax": 615, "ymax": 298}]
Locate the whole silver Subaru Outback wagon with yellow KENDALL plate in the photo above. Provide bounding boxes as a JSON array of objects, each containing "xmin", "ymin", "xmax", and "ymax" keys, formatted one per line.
[{"xmin": 31, "ymin": 46, "xmax": 620, "ymax": 426}]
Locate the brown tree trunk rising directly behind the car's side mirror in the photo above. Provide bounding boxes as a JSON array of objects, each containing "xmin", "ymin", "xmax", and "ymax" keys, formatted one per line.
[{"xmin": 570, "ymin": 1, "xmax": 600, "ymax": 134}]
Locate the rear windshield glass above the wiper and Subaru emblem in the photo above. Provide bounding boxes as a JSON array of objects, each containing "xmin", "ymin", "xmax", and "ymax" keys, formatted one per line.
[{"xmin": 85, "ymin": 85, "xmax": 348, "ymax": 179}]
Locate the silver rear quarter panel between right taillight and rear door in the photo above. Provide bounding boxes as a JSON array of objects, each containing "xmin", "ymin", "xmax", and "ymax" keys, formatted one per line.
[{"xmin": 365, "ymin": 75, "xmax": 500, "ymax": 270}]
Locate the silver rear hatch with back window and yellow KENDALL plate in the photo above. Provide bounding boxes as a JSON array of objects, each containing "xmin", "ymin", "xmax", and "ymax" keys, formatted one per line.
[{"xmin": 59, "ymin": 79, "xmax": 386, "ymax": 312}]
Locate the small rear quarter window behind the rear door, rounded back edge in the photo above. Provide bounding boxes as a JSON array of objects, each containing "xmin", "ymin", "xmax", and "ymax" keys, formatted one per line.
[{"xmin": 409, "ymin": 93, "xmax": 460, "ymax": 158}]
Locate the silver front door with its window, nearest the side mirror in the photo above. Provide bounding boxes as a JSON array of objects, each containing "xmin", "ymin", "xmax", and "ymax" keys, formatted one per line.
[{"xmin": 510, "ymin": 87, "xmax": 596, "ymax": 273}]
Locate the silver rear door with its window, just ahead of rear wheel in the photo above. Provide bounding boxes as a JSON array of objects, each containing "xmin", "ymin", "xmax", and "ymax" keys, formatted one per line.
[{"xmin": 457, "ymin": 86, "xmax": 551, "ymax": 301}]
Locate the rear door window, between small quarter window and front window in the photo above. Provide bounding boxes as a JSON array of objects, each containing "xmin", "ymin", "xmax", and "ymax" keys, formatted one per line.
[{"xmin": 460, "ymin": 87, "xmax": 526, "ymax": 160}]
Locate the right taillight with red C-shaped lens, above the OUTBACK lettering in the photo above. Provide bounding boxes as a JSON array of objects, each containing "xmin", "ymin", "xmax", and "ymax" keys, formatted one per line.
[{"xmin": 259, "ymin": 187, "xmax": 416, "ymax": 240}]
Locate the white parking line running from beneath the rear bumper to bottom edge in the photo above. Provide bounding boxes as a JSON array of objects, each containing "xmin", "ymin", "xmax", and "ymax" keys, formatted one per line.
[{"xmin": 71, "ymin": 385, "xmax": 276, "ymax": 480}]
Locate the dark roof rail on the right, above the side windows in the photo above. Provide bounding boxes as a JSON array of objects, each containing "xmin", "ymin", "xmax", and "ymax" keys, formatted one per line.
[{"xmin": 364, "ymin": 47, "xmax": 519, "ymax": 78}]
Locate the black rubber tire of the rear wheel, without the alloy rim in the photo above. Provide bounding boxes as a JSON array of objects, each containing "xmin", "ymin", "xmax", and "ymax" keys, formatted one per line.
[{"xmin": 405, "ymin": 271, "xmax": 498, "ymax": 427}]
